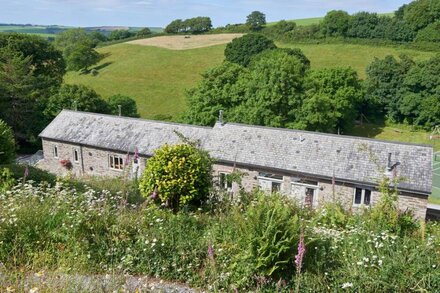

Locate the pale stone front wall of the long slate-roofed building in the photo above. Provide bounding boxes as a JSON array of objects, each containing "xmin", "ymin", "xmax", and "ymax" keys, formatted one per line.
[{"xmin": 38, "ymin": 139, "xmax": 428, "ymax": 219}]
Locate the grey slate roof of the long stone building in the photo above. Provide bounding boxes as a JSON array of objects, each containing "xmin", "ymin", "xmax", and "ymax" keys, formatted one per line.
[{"xmin": 40, "ymin": 110, "xmax": 433, "ymax": 194}]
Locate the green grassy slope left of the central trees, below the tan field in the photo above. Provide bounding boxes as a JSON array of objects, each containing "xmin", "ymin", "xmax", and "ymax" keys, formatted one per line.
[{"xmin": 65, "ymin": 44, "xmax": 225, "ymax": 118}]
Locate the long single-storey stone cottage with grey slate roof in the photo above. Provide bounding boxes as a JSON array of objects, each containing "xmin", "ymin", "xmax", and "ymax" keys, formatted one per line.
[{"xmin": 39, "ymin": 110, "xmax": 433, "ymax": 218}]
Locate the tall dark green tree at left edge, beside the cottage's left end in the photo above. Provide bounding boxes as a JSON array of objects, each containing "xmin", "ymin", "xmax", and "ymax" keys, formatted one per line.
[{"xmin": 0, "ymin": 34, "xmax": 64, "ymax": 144}]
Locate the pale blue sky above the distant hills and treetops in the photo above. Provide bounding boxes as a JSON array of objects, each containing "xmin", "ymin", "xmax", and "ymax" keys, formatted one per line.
[{"xmin": 0, "ymin": 0, "xmax": 411, "ymax": 27}]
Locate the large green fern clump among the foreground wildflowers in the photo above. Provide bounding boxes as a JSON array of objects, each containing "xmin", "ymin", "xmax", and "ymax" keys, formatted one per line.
[{"xmin": 230, "ymin": 193, "xmax": 300, "ymax": 288}]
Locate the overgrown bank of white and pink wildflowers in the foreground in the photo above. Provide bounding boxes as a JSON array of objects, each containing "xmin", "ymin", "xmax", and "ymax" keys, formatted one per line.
[{"xmin": 0, "ymin": 177, "xmax": 440, "ymax": 292}]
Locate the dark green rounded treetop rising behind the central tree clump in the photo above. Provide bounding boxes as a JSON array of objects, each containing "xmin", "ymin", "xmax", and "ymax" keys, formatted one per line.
[{"xmin": 225, "ymin": 34, "xmax": 276, "ymax": 66}]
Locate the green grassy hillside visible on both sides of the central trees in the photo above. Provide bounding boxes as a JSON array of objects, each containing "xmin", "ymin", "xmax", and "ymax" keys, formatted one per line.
[{"xmin": 65, "ymin": 39, "xmax": 431, "ymax": 118}]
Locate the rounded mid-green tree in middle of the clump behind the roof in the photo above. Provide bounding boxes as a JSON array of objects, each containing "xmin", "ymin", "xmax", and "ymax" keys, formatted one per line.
[{"xmin": 231, "ymin": 50, "xmax": 304, "ymax": 127}]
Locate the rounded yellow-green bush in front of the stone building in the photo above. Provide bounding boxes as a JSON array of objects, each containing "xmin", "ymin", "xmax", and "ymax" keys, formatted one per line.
[{"xmin": 139, "ymin": 144, "xmax": 212, "ymax": 210}]
